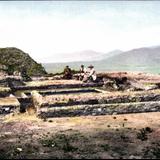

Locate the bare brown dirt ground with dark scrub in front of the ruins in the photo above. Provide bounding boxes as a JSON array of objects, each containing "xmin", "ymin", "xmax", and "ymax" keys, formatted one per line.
[{"xmin": 0, "ymin": 112, "xmax": 160, "ymax": 159}]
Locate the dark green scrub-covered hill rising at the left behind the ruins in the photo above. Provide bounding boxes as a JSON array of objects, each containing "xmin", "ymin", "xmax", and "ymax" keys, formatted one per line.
[{"xmin": 0, "ymin": 47, "xmax": 46, "ymax": 76}]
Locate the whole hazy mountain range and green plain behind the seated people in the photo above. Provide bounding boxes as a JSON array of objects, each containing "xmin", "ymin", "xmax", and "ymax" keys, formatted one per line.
[{"xmin": 43, "ymin": 46, "xmax": 160, "ymax": 73}]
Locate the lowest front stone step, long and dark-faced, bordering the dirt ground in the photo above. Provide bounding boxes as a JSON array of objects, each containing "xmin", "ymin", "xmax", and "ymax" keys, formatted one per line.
[{"xmin": 39, "ymin": 101, "xmax": 160, "ymax": 118}]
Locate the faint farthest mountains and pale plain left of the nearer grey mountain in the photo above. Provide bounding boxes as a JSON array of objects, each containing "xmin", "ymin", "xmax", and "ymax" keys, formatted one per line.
[{"xmin": 43, "ymin": 50, "xmax": 122, "ymax": 73}]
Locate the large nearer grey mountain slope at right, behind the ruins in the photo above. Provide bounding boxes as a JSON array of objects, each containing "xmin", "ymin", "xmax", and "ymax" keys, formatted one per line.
[{"xmin": 94, "ymin": 46, "xmax": 160, "ymax": 73}]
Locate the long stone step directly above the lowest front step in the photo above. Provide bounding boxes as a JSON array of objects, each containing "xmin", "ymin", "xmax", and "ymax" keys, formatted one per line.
[{"xmin": 42, "ymin": 90, "xmax": 160, "ymax": 107}]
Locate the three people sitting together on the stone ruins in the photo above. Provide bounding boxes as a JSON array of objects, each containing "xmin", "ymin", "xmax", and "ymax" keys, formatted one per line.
[{"xmin": 63, "ymin": 65, "xmax": 97, "ymax": 82}]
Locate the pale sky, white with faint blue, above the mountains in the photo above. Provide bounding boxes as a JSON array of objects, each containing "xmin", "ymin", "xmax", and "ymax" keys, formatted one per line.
[{"xmin": 0, "ymin": 1, "xmax": 160, "ymax": 63}]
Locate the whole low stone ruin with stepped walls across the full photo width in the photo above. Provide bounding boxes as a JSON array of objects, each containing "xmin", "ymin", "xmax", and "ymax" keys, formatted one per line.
[{"xmin": 0, "ymin": 74, "xmax": 160, "ymax": 118}]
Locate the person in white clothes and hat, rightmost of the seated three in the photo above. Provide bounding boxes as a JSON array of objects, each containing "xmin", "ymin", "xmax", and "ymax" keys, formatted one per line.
[{"xmin": 83, "ymin": 65, "xmax": 97, "ymax": 82}]
